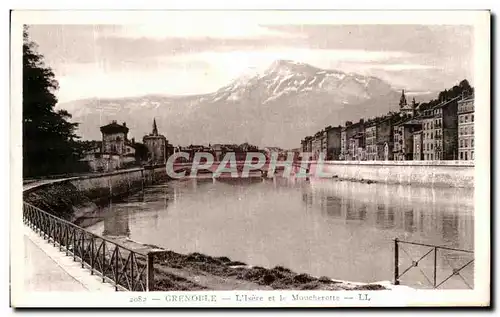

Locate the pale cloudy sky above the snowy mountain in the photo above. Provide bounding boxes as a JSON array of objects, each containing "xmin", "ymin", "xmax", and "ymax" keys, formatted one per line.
[{"xmin": 29, "ymin": 21, "xmax": 474, "ymax": 102}]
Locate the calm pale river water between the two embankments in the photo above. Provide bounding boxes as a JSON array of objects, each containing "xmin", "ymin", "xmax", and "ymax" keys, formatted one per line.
[{"xmin": 89, "ymin": 178, "xmax": 474, "ymax": 288}]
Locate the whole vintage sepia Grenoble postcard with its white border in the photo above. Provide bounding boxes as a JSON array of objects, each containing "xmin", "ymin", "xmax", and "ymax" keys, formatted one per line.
[{"xmin": 10, "ymin": 10, "xmax": 491, "ymax": 308}]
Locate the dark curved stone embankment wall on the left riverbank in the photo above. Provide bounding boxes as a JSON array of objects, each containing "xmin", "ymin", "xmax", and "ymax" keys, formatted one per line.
[{"xmin": 23, "ymin": 165, "xmax": 167, "ymax": 222}]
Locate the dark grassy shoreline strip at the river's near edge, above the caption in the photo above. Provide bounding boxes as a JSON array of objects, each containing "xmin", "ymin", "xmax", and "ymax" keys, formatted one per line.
[{"xmin": 106, "ymin": 233, "xmax": 390, "ymax": 291}]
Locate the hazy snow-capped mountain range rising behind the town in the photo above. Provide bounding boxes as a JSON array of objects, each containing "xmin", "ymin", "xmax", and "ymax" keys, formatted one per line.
[{"xmin": 59, "ymin": 60, "xmax": 418, "ymax": 148}]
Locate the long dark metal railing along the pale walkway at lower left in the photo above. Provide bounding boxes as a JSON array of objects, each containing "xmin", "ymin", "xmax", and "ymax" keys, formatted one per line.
[{"xmin": 23, "ymin": 202, "xmax": 163, "ymax": 292}]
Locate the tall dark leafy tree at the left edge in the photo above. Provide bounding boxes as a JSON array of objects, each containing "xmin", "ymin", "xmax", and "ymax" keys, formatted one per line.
[{"xmin": 23, "ymin": 27, "xmax": 79, "ymax": 176}]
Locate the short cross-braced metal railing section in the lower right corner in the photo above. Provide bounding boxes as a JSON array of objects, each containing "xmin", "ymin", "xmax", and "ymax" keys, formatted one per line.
[{"xmin": 394, "ymin": 238, "xmax": 474, "ymax": 289}]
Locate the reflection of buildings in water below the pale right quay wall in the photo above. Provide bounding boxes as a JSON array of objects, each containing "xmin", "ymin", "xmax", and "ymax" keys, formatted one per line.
[{"xmin": 302, "ymin": 180, "xmax": 474, "ymax": 249}]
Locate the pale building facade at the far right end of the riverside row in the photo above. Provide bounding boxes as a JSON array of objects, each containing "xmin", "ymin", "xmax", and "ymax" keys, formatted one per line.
[{"xmin": 457, "ymin": 95, "xmax": 474, "ymax": 161}]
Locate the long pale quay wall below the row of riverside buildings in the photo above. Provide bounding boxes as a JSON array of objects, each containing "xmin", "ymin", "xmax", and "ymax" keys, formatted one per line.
[{"xmin": 310, "ymin": 161, "xmax": 474, "ymax": 188}]
